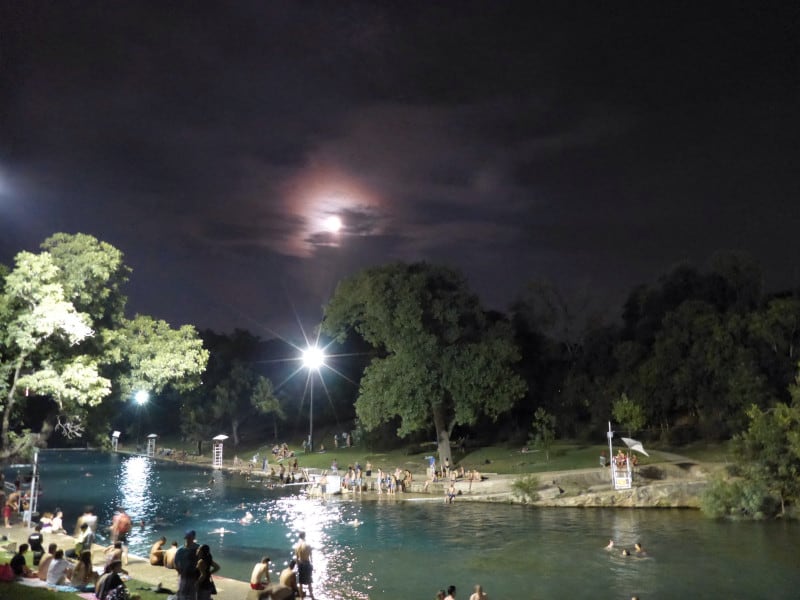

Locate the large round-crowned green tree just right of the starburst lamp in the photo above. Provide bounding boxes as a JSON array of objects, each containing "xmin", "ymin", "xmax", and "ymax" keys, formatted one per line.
[{"xmin": 322, "ymin": 263, "xmax": 525, "ymax": 468}]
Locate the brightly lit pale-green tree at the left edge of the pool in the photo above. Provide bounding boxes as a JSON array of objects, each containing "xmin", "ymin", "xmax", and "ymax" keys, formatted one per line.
[{"xmin": 0, "ymin": 234, "xmax": 208, "ymax": 456}]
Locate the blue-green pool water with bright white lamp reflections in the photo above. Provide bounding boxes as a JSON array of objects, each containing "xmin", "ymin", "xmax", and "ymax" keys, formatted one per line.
[{"xmin": 26, "ymin": 452, "xmax": 800, "ymax": 600}]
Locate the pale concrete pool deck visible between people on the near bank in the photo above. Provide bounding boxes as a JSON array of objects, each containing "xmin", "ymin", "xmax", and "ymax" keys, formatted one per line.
[{"xmin": 0, "ymin": 523, "xmax": 250, "ymax": 600}]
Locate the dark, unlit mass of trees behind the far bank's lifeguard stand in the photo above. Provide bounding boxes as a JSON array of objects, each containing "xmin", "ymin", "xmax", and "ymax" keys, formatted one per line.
[{"xmin": 512, "ymin": 255, "xmax": 800, "ymax": 443}]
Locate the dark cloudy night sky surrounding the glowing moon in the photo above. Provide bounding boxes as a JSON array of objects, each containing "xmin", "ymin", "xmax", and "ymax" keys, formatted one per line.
[{"xmin": 0, "ymin": 0, "xmax": 800, "ymax": 338}]
